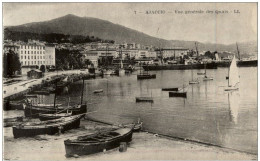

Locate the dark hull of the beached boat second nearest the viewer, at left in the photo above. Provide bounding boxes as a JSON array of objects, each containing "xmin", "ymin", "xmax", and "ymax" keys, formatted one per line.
[{"xmin": 13, "ymin": 115, "xmax": 84, "ymax": 138}]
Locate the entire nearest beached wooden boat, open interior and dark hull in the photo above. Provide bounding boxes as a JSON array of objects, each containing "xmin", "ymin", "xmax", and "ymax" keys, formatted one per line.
[{"xmin": 64, "ymin": 128, "xmax": 133, "ymax": 157}]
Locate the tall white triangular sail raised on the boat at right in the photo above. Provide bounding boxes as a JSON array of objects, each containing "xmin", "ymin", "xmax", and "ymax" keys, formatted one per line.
[{"xmin": 228, "ymin": 56, "xmax": 239, "ymax": 87}]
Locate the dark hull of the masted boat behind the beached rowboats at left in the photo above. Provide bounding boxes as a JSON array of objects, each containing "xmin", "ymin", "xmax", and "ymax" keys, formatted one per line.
[{"xmin": 24, "ymin": 105, "xmax": 87, "ymax": 118}]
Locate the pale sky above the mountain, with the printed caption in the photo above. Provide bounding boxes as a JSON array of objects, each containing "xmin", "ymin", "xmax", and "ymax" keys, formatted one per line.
[{"xmin": 3, "ymin": 3, "xmax": 257, "ymax": 44}]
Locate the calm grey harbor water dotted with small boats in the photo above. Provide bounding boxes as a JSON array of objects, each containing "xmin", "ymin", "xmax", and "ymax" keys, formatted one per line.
[{"xmin": 5, "ymin": 67, "xmax": 257, "ymax": 154}]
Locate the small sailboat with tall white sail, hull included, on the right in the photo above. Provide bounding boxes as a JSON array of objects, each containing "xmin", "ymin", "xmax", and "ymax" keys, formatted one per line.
[{"xmin": 225, "ymin": 55, "xmax": 239, "ymax": 91}]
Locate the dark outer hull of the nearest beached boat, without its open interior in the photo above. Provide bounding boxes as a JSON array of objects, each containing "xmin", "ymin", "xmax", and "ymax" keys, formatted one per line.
[{"xmin": 64, "ymin": 127, "xmax": 133, "ymax": 157}]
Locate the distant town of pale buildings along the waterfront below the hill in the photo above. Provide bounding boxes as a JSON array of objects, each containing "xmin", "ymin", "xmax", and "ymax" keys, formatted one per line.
[{"xmin": 3, "ymin": 40, "xmax": 255, "ymax": 75}]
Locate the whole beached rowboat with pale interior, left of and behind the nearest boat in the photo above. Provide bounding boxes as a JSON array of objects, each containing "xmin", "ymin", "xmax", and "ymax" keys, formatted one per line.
[{"xmin": 13, "ymin": 114, "xmax": 85, "ymax": 138}]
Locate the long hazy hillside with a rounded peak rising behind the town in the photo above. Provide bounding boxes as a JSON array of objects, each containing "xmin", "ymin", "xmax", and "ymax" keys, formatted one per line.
[{"xmin": 5, "ymin": 14, "xmax": 257, "ymax": 55}]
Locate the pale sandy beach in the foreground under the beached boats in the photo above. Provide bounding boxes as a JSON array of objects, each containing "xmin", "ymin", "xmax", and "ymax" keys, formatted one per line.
[{"xmin": 4, "ymin": 120, "xmax": 257, "ymax": 160}]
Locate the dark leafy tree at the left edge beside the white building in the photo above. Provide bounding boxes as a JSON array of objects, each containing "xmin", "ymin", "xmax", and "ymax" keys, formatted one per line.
[{"xmin": 3, "ymin": 50, "xmax": 21, "ymax": 77}]
